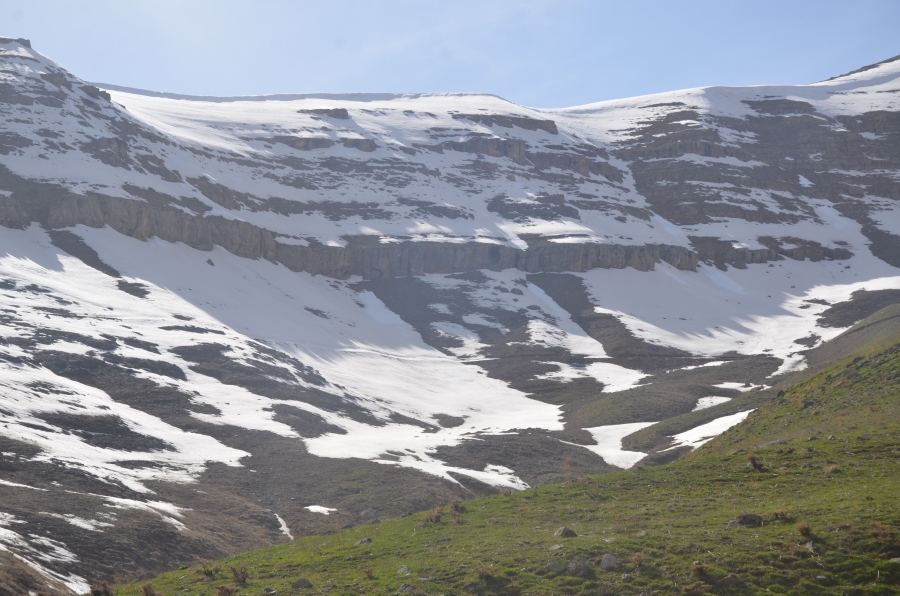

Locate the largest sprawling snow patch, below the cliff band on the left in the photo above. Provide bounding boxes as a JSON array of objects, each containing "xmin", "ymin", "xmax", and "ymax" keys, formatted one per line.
[{"xmin": 10, "ymin": 227, "xmax": 568, "ymax": 488}]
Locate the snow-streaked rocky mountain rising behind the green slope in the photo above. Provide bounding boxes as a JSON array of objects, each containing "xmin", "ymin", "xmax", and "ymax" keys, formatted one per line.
[{"xmin": 0, "ymin": 38, "xmax": 900, "ymax": 593}]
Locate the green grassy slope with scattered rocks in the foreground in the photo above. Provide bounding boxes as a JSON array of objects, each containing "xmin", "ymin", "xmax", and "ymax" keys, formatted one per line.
[{"xmin": 112, "ymin": 336, "xmax": 900, "ymax": 596}]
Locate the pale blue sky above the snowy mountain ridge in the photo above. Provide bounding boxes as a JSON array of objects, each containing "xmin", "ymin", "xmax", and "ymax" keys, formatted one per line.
[{"xmin": 7, "ymin": 0, "xmax": 900, "ymax": 108}]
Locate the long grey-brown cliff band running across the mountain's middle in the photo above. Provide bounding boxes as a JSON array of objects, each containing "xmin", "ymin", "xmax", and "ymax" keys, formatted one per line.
[{"xmin": 0, "ymin": 168, "xmax": 698, "ymax": 279}]
